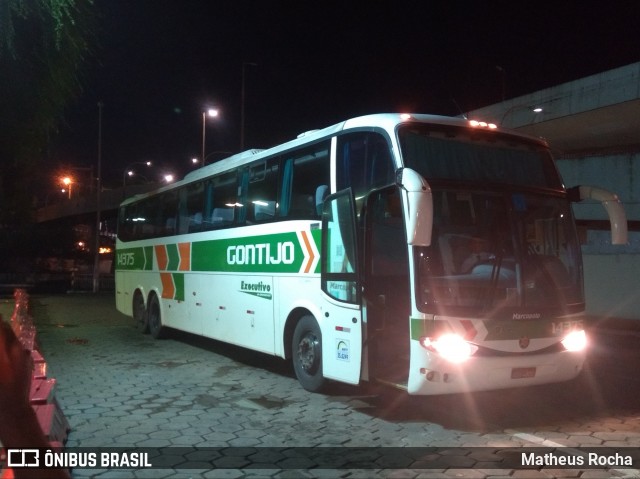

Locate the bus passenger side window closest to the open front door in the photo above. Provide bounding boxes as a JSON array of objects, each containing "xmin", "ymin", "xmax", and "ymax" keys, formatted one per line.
[{"xmin": 280, "ymin": 141, "xmax": 330, "ymax": 219}]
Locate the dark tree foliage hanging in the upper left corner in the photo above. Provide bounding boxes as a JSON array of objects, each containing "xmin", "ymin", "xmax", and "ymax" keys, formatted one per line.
[{"xmin": 0, "ymin": 0, "xmax": 95, "ymax": 224}]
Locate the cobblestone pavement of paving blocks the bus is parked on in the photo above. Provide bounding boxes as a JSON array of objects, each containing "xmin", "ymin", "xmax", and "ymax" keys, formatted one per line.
[{"xmin": 11, "ymin": 294, "xmax": 640, "ymax": 479}]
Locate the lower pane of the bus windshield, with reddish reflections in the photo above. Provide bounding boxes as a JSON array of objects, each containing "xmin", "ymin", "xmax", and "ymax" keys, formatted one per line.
[{"xmin": 415, "ymin": 190, "xmax": 583, "ymax": 315}]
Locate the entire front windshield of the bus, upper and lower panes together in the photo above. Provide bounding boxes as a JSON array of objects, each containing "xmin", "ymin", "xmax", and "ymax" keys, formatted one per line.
[{"xmin": 400, "ymin": 127, "xmax": 584, "ymax": 317}]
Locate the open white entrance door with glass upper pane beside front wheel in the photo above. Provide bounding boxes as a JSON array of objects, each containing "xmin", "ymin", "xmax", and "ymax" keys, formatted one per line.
[{"xmin": 321, "ymin": 188, "xmax": 362, "ymax": 384}]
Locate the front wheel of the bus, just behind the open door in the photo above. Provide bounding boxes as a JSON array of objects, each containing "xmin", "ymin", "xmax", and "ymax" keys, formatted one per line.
[{"xmin": 291, "ymin": 315, "xmax": 326, "ymax": 392}]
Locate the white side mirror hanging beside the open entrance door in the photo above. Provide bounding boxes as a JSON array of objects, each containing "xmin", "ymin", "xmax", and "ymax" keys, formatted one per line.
[{"xmin": 396, "ymin": 168, "xmax": 433, "ymax": 246}]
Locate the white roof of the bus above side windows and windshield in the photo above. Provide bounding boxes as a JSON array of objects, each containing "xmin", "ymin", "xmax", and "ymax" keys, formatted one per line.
[{"xmin": 122, "ymin": 113, "xmax": 546, "ymax": 205}]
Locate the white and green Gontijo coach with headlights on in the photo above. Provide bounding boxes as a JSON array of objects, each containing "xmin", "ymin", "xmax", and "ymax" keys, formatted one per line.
[{"xmin": 116, "ymin": 114, "xmax": 626, "ymax": 394}]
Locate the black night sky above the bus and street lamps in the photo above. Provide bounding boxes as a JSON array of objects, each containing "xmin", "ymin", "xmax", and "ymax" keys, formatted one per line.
[{"xmin": 51, "ymin": 0, "xmax": 640, "ymax": 186}]
